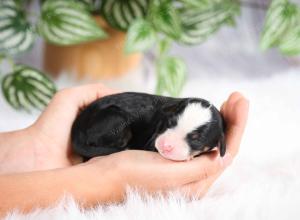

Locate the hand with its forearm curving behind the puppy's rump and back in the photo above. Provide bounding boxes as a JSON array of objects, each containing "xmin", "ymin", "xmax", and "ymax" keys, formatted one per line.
[{"xmin": 0, "ymin": 83, "xmax": 116, "ymax": 173}]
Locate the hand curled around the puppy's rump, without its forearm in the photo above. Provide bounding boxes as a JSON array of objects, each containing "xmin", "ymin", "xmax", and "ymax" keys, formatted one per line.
[{"xmin": 31, "ymin": 83, "xmax": 117, "ymax": 168}]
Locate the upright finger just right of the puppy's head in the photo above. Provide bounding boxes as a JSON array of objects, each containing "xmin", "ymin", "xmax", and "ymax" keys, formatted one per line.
[{"xmin": 226, "ymin": 99, "xmax": 249, "ymax": 157}]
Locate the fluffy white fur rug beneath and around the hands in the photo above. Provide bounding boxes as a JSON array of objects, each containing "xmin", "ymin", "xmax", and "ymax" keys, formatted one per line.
[{"xmin": 0, "ymin": 70, "xmax": 300, "ymax": 220}]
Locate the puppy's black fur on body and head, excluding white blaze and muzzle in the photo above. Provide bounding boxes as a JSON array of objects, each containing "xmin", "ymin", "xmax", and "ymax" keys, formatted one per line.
[{"xmin": 71, "ymin": 92, "xmax": 226, "ymax": 159}]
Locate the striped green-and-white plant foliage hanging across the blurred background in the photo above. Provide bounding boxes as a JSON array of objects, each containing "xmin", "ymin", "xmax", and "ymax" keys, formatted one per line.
[{"xmin": 0, "ymin": 0, "xmax": 300, "ymax": 110}]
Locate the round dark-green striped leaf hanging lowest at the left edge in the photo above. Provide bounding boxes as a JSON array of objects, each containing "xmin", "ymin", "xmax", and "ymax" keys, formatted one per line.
[{"xmin": 2, "ymin": 65, "xmax": 56, "ymax": 111}]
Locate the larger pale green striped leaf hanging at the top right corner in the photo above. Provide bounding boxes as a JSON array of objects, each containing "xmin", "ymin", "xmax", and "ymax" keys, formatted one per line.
[{"xmin": 260, "ymin": 0, "xmax": 297, "ymax": 50}]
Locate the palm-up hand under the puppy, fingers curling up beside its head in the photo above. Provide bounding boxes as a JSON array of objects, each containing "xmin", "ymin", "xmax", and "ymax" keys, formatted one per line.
[{"xmin": 88, "ymin": 92, "xmax": 249, "ymax": 200}]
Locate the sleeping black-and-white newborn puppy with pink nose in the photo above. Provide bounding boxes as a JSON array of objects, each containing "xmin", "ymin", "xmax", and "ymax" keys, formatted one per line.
[{"xmin": 71, "ymin": 92, "xmax": 226, "ymax": 161}]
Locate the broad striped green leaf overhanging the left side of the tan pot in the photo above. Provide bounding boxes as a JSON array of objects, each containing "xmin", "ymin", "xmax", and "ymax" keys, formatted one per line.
[{"xmin": 39, "ymin": 0, "xmax": 107, "ymax": 45}]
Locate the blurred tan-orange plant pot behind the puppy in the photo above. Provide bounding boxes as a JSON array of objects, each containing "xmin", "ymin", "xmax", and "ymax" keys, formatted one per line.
[{"xmin": 44, "ymin": 17, "xmax": 142, "ymax": 79}]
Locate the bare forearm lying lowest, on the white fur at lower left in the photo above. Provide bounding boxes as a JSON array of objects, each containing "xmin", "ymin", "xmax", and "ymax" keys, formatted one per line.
[{"xmin": 0, "ymin": 165, "xmax": 122, "ymax": 216}]
